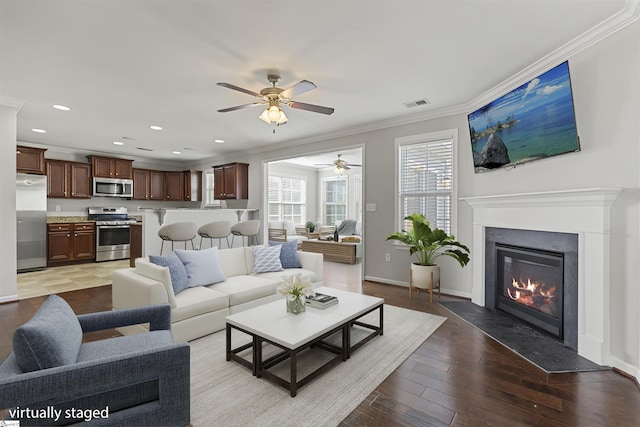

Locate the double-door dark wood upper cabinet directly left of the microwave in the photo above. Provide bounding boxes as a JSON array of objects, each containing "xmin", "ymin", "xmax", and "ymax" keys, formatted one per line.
[{"xmin": 45, "ymin": 160, "xmax": 91, "ymax": 199}]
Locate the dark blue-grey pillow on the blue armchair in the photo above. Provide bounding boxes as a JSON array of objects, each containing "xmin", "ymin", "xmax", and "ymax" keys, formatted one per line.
[{"xmin": 13, "ymin": 295, "xmax": 82, "ymax": 372}]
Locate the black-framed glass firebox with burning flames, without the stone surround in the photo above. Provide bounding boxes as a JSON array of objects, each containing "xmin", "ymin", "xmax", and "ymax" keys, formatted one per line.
[{"xmin": 495, "ymin": 244, "xmax": 564, "ymax": 339}]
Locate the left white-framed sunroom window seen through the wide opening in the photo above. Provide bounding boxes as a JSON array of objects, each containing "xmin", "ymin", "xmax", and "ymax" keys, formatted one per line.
[{"xmin": 268, "ymin": 176, "xmax": 307, "ymax": 225}]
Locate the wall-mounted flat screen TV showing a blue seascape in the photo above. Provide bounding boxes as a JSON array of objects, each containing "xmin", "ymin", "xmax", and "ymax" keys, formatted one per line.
[{"xmin": 468, "ymin": 62, "xmax": 580, "ymax": 172}]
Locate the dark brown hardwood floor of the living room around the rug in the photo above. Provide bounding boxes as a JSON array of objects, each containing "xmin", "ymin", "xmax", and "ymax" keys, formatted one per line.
[{"xmin": 0, "ymin": 281, "xmax": 640, "ymax": 427}]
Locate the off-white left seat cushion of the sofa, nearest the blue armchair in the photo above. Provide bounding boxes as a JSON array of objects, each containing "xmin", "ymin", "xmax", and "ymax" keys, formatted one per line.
[{"xmin": 171, "ymin": 282, "xmax": 229, "ymax": 323}]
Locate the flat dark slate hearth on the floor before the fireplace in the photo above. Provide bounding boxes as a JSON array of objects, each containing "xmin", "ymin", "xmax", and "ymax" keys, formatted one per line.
[{"xmin": 440, "ymin": 301, "xmax": 610, "ymax": 373}]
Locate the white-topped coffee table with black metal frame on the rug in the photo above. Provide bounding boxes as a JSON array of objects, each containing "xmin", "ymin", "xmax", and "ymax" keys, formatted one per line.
[{"xmin": 226, "ymin": 287, "xmax": 384, "ymax": 397}]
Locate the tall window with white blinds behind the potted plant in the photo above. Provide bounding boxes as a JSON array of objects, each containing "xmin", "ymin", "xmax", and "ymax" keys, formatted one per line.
[{"xmin": 396, "ymin": 131, "xmax": 456, "ymax": 234}]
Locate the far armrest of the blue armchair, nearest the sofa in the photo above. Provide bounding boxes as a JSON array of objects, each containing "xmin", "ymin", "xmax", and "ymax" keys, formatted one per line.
[{"xmin": 77, "ymin": 304, "xmax": 171, "ymax": 332}]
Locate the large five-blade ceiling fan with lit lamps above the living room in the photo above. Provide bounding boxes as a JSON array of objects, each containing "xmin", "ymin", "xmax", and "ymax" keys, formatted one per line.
[{"xmin": 218, "ymin": 74, "xmax": 334, "ymax": 127}]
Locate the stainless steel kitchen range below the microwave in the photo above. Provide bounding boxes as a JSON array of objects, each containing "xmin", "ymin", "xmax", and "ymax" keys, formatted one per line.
[{"xmin": 88, "ymin": 207, "xmax": 137, "ymax": 262}]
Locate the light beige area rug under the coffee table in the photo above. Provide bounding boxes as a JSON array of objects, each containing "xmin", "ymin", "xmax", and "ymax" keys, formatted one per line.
[{"xmin": 189, "ymin": 305, "xmax": 446, "ymax": 427}]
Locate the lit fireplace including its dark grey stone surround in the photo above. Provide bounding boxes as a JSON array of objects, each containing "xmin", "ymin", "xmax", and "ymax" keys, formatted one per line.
[{"xmin": 485, "ymin": 227, "xmax": 578, "ymax": 350}]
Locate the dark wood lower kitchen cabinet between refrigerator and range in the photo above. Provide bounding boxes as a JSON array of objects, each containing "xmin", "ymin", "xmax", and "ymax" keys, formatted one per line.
[{"xmin": 47, "ymin": 222, "xmax": 96, "ymax": 265}]
